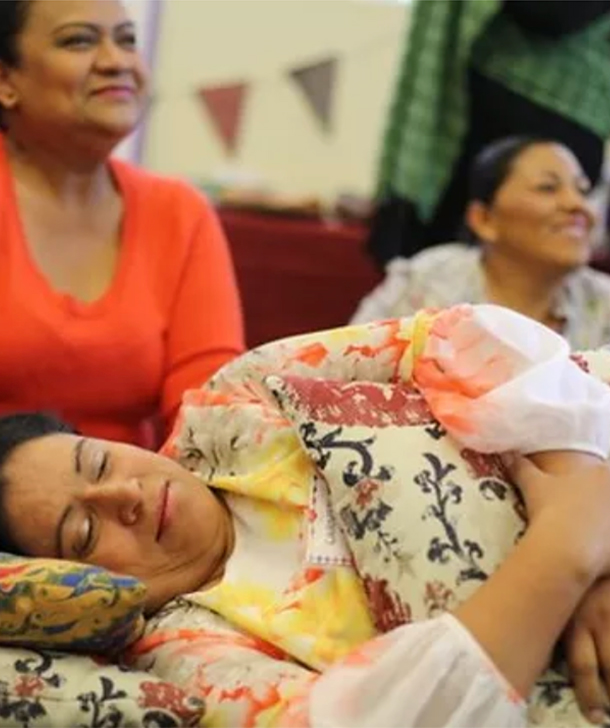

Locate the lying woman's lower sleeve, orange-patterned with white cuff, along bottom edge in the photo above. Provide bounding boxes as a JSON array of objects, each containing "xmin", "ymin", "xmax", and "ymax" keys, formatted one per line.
[{"xmin": 131, "ymin": 609, "xmax": 523, "ymax": 728}]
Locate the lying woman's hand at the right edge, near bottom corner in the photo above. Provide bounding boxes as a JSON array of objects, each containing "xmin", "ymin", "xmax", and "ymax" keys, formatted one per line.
[{"xmin": 564, "ymin": 578, "xmax": 610, "ymax": 723}]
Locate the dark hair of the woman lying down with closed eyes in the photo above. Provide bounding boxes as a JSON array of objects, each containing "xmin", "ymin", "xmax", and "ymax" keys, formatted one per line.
[{"xmin": 0, "ymin": 412, "xmax": 76, "ymax": 556}]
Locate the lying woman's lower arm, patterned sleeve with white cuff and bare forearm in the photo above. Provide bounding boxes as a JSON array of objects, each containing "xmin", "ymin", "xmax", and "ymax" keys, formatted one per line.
[{"xmin": 129, "ymin": 452, "xmax": 610, "ymax": 728}]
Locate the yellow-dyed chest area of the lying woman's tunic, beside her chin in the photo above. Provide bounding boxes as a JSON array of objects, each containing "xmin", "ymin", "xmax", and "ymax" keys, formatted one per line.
[{"xmin": 190, "ymin": 447, "xmax": 375, "ymax": 669}]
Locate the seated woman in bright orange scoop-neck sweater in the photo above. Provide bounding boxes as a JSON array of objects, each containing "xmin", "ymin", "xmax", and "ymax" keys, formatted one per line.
[{"xmin": 0, "ymin": 0, "xmax": 243, "ymax": 446}]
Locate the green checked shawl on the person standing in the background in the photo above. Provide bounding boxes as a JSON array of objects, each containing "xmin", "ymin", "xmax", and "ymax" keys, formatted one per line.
[{"xmin": 377, "ymin": 0, "xmax": 610, "ymax": 222}]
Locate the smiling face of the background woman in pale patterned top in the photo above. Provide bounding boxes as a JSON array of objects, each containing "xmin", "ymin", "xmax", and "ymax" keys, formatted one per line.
[{"xmin": 467, "ymin": 143, "xmax": 595, "ymax": 270}]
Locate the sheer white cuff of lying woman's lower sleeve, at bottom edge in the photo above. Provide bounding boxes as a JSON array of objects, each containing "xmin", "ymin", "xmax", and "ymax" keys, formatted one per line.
[{"xmin": 310, "ymin": 614, "xmax": 526, "ymax": 728}]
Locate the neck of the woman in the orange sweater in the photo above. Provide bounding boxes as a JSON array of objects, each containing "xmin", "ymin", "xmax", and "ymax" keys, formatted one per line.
[{"xmin": 5, "ymin": 129, "xmax": 113, "ymax": 205}]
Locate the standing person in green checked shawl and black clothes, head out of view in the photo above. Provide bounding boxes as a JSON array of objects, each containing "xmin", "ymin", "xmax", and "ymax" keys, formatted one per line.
[{"xmin": 368, "ymin": 0, "xmax": 610, "ymax": 265}]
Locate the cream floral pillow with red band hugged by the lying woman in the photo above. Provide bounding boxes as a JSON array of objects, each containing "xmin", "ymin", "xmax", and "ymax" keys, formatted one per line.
[{"xmin": 265, "ymin": 376, "xmax": 604, "ymax": 726}]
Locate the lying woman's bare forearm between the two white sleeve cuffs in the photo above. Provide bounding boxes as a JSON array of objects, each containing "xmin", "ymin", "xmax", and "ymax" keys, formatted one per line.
[{"xmin": 453, "ymin": 453, "xmax": 610, "ymax": 697}]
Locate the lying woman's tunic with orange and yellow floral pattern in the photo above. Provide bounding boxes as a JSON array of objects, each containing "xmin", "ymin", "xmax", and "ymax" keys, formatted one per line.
[{"xmin": 126, "ymin": 307, "xmax": 606, "ymax": 727}]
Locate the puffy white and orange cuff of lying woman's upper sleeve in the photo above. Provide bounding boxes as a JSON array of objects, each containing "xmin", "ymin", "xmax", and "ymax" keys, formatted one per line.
[{"xmin": 424, "ymin": 304, "xmax": 610, "ymax": 459}]
